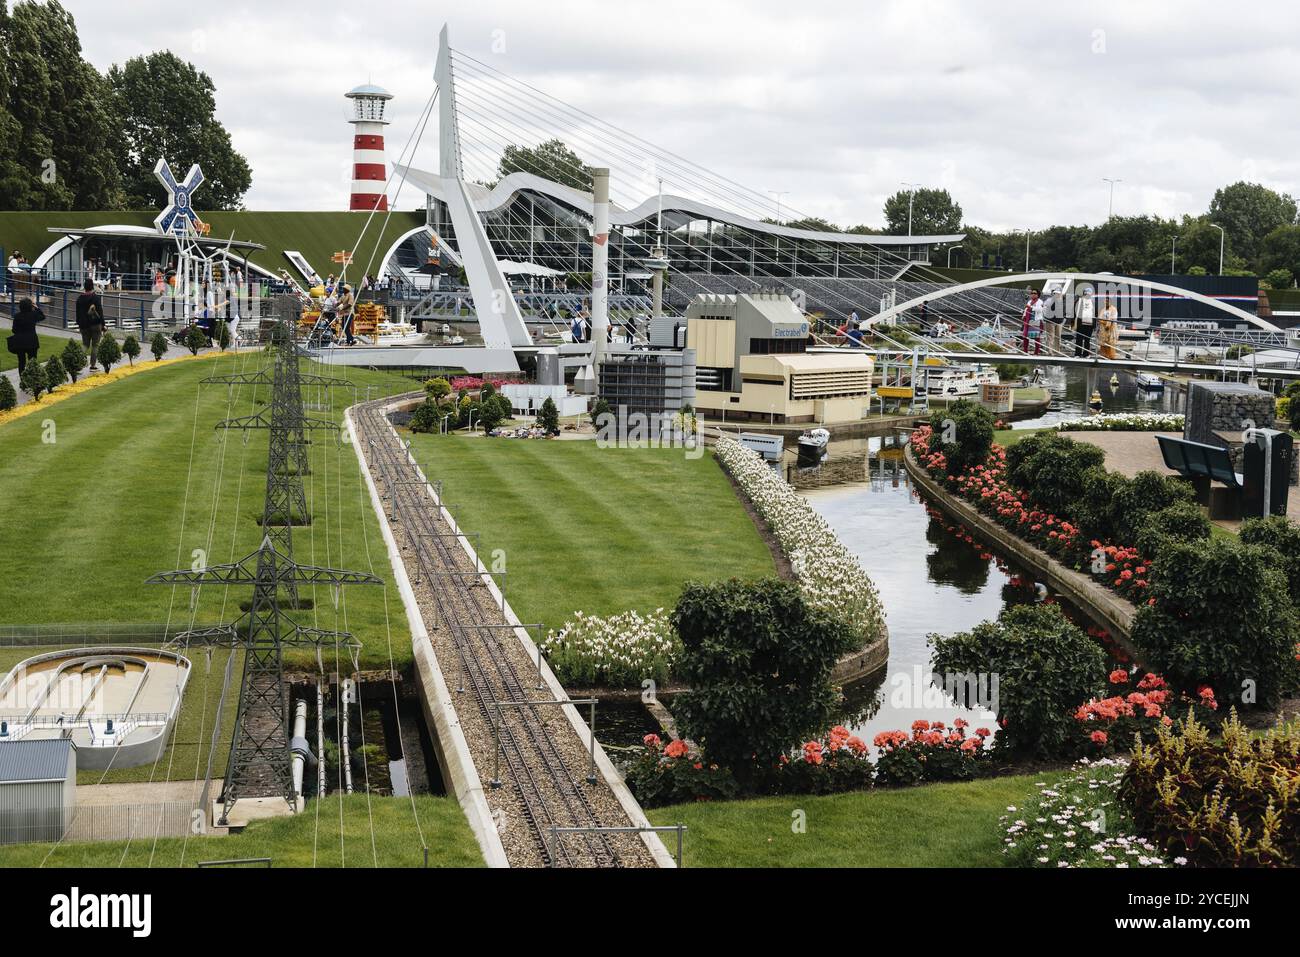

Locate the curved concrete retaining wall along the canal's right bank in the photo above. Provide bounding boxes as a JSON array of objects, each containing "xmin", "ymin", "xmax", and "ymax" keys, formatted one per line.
[{"xmin": 905, "ymin": 446, "xmax": 1140, "ymax": 662}]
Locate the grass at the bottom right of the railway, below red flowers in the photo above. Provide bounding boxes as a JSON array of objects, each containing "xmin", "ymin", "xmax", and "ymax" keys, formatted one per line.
[{"xmin": 647, "ymin": 772, "xmax": 1061, "ymax": 867}]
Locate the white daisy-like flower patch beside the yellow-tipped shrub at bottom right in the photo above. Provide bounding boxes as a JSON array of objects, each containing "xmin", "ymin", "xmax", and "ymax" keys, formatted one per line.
[{"xmin": 1001, "ymin": 758, "xmax": 1187, "ymax": 869}]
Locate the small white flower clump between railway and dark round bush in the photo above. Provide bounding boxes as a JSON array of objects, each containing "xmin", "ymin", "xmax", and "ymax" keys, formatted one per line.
[{"xmin": 542, "ymin": 609, "xmax": 681, "ymax": 687}]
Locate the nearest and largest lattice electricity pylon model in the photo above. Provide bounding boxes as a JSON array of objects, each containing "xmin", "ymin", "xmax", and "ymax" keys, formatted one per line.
[{"xmin": 147, "ymin": 536, "xmax": 384, "ymax": 827}]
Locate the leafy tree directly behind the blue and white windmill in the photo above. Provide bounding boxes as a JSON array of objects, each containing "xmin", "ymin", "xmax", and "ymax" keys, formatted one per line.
[{"xmin": 108, "ymin": 49, "xmax": 252, "ymax": 209}]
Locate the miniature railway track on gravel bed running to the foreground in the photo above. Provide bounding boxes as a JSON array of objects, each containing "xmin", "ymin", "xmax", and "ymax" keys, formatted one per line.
[{"xmin": 355, "ymin": 399, "xmax": 631, "ymax": 867}]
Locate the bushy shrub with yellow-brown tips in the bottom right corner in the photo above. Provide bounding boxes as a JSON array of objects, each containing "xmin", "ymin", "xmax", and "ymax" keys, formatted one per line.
[{"xmin": 1119, "ymin": 710, "xmax": 1300, "ymax": 867}]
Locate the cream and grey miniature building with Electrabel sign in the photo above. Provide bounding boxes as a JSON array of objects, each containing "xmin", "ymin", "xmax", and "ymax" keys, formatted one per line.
[{"xmin": 686, "ymin": 293, "xmax": 872, "ymax": 423}]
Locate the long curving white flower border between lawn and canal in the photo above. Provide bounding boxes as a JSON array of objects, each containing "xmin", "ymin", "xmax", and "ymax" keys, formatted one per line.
[{"xmin": 714, "ymin": 436, "xmax": 884, "ymax": 644}]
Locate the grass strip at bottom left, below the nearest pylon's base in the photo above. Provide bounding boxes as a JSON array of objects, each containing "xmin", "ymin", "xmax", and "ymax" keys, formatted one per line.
[{"xmin": 0, "ymin": 794, "xmax": 482, "ymax": 867}]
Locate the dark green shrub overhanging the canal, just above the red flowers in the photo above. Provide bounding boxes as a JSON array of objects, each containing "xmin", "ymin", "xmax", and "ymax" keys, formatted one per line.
[{"xmin": 930, "ymin": 605, "xmax": 1106, "ymax": 757}]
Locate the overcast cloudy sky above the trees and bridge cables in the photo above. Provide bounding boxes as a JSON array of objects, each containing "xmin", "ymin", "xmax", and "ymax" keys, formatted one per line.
[{"xmin": 64, "ymin": 0, "xmax": 1300, "ymax": 229}]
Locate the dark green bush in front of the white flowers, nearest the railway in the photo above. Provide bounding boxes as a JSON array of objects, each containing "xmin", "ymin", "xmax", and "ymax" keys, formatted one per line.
[{"xmin": 672, "ymin": 579, "xmax": 857, "ymax": 781}]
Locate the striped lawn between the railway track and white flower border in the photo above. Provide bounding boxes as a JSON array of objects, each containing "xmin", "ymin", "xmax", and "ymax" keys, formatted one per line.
[{"xmin": 413, "ymin": 436, "xmax": 775, "ymax": 628}]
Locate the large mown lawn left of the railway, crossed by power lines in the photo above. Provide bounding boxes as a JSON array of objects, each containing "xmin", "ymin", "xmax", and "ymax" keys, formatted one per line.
[{"xmin": 0, "ymin": 352, "xmax": 411, "ymax": 670}]
